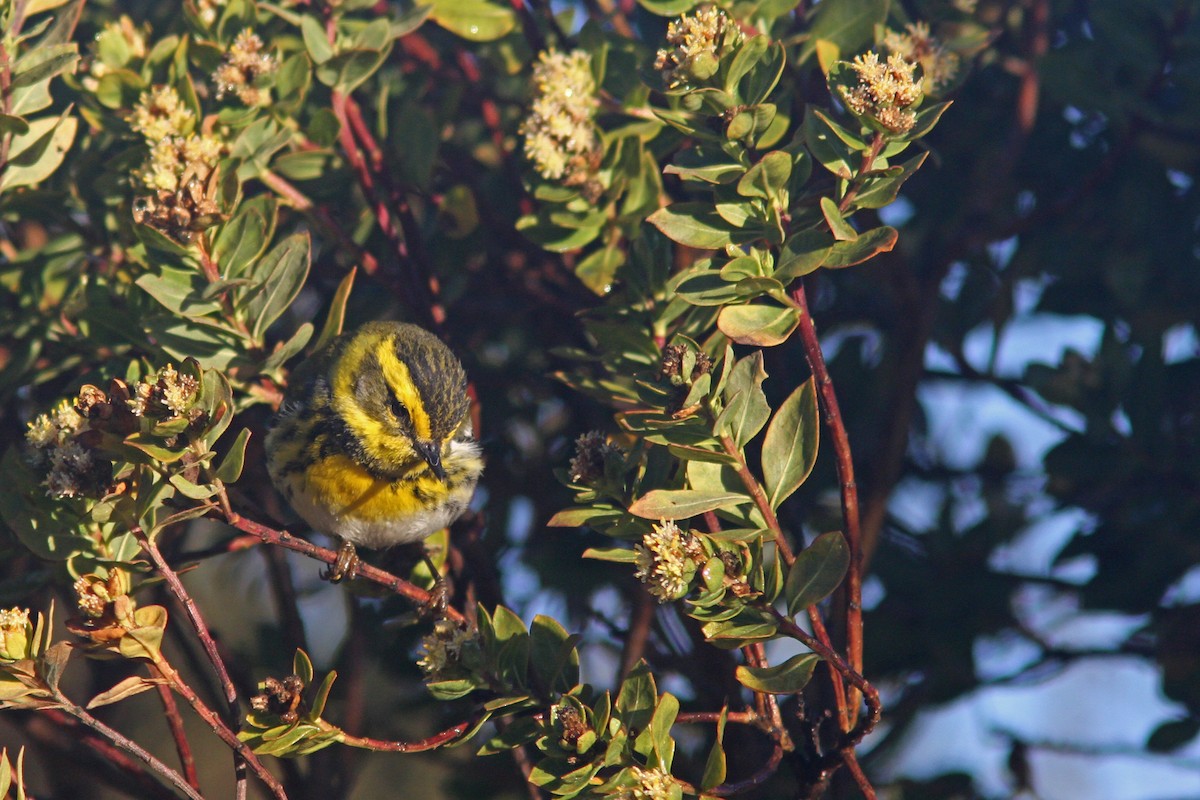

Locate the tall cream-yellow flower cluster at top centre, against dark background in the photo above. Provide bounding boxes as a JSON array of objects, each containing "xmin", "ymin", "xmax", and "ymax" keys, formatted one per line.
[{"xmin": 521, "ymin": 50, "xmax": 600, "ymax": 186}]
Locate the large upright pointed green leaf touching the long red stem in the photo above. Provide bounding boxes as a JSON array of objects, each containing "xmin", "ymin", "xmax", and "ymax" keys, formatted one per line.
[{"xmin": 762, "ymin": 378, "xmax": 821, "ymax": 509}]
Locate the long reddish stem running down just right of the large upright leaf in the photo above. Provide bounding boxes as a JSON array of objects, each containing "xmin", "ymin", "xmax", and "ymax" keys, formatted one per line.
[{"xmin": 792, "ymin": 282, "xmax": 863, "ymax": 730}]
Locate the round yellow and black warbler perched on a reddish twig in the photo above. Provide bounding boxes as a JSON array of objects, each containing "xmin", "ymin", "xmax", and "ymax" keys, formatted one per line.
[{"xmin": 266, "ymin": 323, "xmax": 484, "ymax": 582}]
